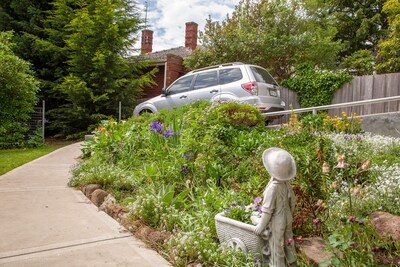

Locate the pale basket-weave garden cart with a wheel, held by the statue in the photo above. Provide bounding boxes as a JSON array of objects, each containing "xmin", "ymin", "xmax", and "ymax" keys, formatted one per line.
[{"xmin": 215, "ymin": 212, "xmax": 269, "ymax": 257}]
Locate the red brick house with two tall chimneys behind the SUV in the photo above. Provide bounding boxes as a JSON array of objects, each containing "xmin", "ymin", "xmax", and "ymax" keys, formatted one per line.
[{"xmin": 141, "ymin": 22, "xmax": 198, "ymax": 99}]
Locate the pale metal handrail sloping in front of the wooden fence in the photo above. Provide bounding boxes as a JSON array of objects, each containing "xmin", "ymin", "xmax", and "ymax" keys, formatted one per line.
[{"xmin": 264, "ymin": 95, "xmax": 400, "ymax": 117}]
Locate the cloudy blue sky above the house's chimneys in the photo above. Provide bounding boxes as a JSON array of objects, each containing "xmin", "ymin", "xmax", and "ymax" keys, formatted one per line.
[{"xmin": 135, "ymin": 0, "xmax": 239, "ymax": 52}]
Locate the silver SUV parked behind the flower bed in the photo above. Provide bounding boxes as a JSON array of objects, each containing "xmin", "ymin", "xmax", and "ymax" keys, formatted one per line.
[{"xmin": 133, "ymin": 62, "xmax": 285, "ymax": 118}]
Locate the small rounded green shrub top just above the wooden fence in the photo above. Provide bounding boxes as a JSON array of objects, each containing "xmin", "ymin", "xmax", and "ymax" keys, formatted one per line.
[{"xmin": 343, "ymin": 50, "xmax": 375, "ymax": 76}]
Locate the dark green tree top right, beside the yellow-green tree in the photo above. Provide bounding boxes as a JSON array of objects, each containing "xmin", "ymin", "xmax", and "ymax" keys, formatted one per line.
[{"xmin": 326, "ymin": 0, "xmax": 387, "ymax": 57}]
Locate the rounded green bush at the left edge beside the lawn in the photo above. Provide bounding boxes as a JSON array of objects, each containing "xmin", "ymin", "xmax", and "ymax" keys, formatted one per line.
[{"xmin": 0, "ymin": 32, "xmax": 39, "ymax": 148}]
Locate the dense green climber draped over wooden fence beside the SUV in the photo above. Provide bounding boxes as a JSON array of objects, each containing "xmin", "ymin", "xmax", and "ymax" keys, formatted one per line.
[{"xmin": 282, "ymin": 64, "xmax": 352, "ymax": 108}]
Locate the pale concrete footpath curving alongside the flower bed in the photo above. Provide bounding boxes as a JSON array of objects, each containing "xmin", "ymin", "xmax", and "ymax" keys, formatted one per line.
[{"xmin": 0, "ymin": 144, "xmax": 170, "ymax": 267}]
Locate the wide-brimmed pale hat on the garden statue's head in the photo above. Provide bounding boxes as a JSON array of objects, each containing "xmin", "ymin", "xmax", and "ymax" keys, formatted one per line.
[{"xmin": 263, "ymin": 147, "xmax": 296, "ymax": 181}]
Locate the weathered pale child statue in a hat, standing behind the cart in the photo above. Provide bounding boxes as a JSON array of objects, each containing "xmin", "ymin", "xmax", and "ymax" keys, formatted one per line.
[{"xmin": 254, "ymin": 147, "xmax": 297, "ymax": 267}]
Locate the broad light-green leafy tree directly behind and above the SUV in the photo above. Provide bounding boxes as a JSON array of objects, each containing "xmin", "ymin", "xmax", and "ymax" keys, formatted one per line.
[{"xmin": 185, "ymin": 0, "xmax": 341, "ymax": 79}]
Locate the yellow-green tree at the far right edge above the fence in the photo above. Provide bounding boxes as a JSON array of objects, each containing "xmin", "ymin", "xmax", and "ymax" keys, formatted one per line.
[{"xmin": 378, "ymin": 0, "xmax": 400, "ymax": 73}]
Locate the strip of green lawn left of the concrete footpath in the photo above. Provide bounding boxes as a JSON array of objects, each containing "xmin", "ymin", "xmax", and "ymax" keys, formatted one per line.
[{"xmin": 0, "ymin": 140, "xmax": 73, "ymax": 175}]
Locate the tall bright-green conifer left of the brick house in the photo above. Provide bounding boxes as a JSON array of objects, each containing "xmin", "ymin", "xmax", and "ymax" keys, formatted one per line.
[{"xmin": 48, "ymin": 0, "xmax": 152, "ymax": 137}]
